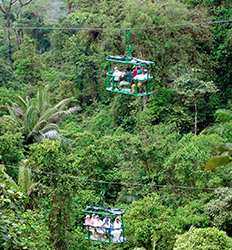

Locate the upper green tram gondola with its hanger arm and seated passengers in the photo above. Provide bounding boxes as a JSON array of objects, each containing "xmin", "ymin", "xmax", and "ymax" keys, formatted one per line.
[{"xmin": 106, "ymin": 31, "xmax": 154, "ymax": 96}]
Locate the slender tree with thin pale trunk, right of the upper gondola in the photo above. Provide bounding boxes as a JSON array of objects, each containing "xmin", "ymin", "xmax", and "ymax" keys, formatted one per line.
[{"xmin": 174, "ymin": 69, "xmax": 217, "ymax": 135}]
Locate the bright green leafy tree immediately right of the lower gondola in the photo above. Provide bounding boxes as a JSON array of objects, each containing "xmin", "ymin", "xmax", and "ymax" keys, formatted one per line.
[{"xmin": 125, "ymin": 194, "xmax": 172, "ymax": 249}]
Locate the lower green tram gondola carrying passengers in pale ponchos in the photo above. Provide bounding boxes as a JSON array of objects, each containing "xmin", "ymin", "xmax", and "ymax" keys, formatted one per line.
[{"xmin": 83, "ymin": 206, "xmax": 125, "ymax": 244}]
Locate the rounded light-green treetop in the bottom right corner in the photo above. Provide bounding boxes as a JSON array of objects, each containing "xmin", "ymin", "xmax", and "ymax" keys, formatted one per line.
[{"xmin": 173, "ymin": 228, "xmax": 232, "ymax": 250}]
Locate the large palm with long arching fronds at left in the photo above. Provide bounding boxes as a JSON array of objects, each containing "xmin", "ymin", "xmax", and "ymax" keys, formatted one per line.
[{"xmin": 8, "ymin": 86, "xmax": 70, "ymax": 145}]
